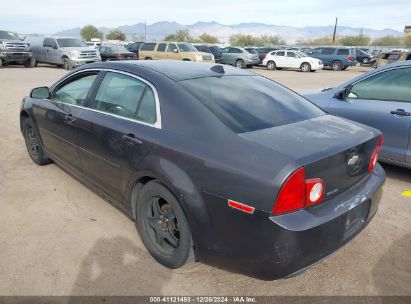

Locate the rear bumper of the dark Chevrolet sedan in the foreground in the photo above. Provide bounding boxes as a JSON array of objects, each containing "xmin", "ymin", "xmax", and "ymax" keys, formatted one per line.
[{"xmin": 196, "ymin": 165, "xmax": 385, "ymax": 280}]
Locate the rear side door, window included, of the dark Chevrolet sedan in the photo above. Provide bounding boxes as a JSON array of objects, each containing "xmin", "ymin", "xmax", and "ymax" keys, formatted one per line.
[{"xmin": 79, "ymin": 71, "xmax": 161, "ymax": 201}]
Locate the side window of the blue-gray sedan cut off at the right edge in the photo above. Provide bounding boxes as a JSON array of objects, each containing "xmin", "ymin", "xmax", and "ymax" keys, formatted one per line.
[{"xmin": 348, "ymin": 68, "xmax": 411, "ymax": 102}]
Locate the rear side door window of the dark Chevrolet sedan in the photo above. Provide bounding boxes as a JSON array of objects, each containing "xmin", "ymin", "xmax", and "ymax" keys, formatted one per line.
[{"xmin": 92, "ymin": 72, "xmax": 157, "ymax": 123}]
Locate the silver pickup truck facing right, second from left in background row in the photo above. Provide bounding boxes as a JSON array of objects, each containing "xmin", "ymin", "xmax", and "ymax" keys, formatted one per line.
[{"xmin": 26, "ymin": 37, "xmax": 101, "ymax": 70}]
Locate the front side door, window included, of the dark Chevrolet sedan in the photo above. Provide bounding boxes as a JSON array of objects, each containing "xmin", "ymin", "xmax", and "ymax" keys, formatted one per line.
[{"xmin": 34, "ymin": 72, "xmax": 97, "ymax": 172}]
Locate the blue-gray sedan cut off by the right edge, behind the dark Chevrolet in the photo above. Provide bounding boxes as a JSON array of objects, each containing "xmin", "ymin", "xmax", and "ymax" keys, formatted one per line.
[{"xmin": 305, "ymin": 61, "xmax": 411, "ymax": 168}]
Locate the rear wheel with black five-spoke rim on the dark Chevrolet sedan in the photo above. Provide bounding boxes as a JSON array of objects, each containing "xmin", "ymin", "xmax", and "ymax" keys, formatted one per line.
[{"xmin": 136, "ymin": 181, "xmax": 194, "ymax": 269}]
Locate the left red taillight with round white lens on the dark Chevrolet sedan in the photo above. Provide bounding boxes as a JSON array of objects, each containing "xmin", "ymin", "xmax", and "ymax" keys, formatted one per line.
[{"xmin": 272, "ymin": 167, "xmax": 324, "ymax": 214}]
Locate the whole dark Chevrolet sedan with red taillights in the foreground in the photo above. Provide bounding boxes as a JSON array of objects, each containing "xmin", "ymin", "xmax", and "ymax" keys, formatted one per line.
[{"xmin": 20, "ymin": 61, "xmax": 385, "ymax": 279}]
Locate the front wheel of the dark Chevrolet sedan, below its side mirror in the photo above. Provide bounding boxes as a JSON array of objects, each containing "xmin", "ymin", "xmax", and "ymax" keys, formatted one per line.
[{"xmin": 23, "ymin": 118, "xmax": 50, "ymax": 166}]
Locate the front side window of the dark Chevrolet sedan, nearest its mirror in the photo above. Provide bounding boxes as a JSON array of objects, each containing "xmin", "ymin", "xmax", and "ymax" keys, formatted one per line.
[{"xmin": 52, "ymin": 73, "xmax": 97, "ymax": 106}]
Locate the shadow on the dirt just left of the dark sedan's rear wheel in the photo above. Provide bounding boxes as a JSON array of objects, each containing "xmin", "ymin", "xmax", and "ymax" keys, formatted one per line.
[{"xmin": 69, "ymin": 236, "xmax": 171, "ymax": 296}]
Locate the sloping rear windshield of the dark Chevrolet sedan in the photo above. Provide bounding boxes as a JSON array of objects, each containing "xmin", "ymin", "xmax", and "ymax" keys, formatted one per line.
[{"xmin": 180, "ymin": 76, "xmax": 324, "ymax": 133}]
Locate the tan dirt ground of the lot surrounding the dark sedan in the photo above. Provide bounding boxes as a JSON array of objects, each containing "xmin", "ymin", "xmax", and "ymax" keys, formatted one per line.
[{"xmin": 0, "ymin": 65, "xmax": 411, "ymax": 295}]
